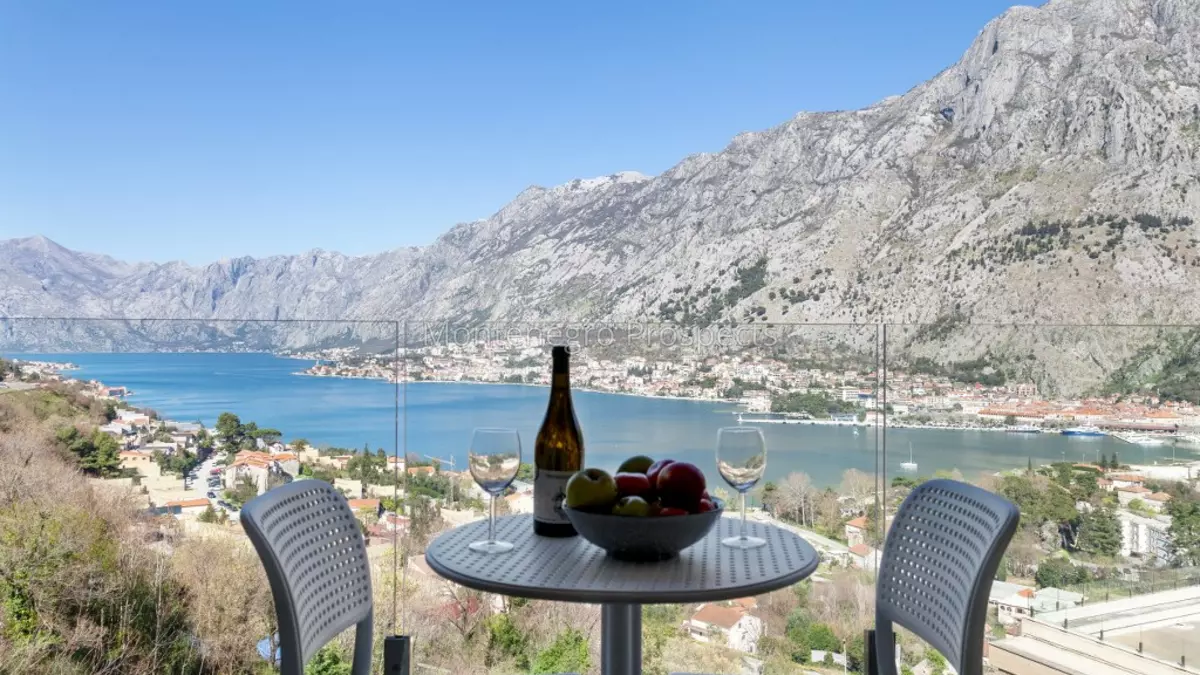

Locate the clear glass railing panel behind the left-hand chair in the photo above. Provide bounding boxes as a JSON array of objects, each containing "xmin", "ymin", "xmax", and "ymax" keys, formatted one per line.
[{"xmin": 0, "ymin": 318, "xmax": 400, "ymax": 673}]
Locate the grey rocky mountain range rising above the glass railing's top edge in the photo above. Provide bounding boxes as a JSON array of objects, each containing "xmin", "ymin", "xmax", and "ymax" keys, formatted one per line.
[{"xmin": 0, "ymin": 0, "xmax": 1200, "ymax": 389}]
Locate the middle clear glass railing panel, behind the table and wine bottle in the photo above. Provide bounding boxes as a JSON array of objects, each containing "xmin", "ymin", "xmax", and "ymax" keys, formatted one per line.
[{"xmin": 403, "ymin": 322, "xmax": 881, "ymax": 673}]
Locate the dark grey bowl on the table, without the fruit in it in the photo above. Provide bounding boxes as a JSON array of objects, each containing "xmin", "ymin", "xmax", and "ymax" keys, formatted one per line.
[{"xmin": 563, "ymin": 498, "xmax": 725, "ymax": 562}]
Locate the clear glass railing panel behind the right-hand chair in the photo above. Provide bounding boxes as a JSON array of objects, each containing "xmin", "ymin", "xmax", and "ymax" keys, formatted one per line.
[{"xmin": 881, "ymin": 322, "xmax": 1200, "ymax": 671}]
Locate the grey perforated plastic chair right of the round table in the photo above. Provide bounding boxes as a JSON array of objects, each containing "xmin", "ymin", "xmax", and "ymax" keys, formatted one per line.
[{"xmin": 875, "ymin": 480, "xmax": 1020, "ymax": 675}]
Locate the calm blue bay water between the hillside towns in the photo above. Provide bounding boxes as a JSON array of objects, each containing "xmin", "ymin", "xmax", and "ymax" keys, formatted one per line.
[{"xmin": 24, "ymin": 353, "xmax": 1188, "ymax": 485}]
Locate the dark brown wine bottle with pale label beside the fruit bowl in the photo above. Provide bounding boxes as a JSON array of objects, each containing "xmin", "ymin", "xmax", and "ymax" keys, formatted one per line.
[{"xmin": 533, "ymin": 347, "xmax": 583, "ymax": 537}]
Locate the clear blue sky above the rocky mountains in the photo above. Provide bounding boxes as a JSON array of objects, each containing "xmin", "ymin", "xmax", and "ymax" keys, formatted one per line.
[{"xmin": 0, "ymin": 0, "xmax": 1041, "ymax": 263}]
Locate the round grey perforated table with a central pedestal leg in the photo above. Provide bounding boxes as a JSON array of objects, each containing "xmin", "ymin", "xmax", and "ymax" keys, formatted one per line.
[{"xmin": 425, "ymin": 515, "xmax": 820, "ymax": 675}]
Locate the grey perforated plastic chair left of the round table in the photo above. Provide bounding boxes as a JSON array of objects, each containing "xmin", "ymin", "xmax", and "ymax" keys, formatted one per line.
[{"xmin": 241, "ymin": 480, "xmax": 373, "ymax": 675}]
